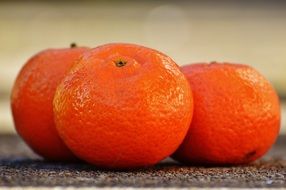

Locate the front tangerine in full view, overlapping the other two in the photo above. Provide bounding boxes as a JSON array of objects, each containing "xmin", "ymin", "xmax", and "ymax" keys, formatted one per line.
[{"xmin": 54, "ymin": 44, "xmax": 193, "ymax": 169}]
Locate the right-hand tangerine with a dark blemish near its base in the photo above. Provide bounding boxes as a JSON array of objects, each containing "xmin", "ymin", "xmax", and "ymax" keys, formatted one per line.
[{"xmin": 173, "ymin": 63, "xmax": 280, "ymax": 165}]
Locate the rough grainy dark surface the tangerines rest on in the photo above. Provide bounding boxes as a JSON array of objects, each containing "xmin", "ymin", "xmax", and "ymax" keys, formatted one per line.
[{"xmin": 0, "ymin": 135, "xmax": 286, "ymax": 188}]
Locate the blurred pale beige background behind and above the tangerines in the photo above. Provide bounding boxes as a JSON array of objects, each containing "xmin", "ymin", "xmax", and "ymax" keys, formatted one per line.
[{"xmin": 0, "ymin": 0, "xmax": 286, "ymax": 134}]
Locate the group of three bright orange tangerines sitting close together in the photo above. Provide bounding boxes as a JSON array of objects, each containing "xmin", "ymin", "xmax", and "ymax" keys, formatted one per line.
[{"xmin": 11, "ymin": 43, "xmax": 280, "ymax": 169}]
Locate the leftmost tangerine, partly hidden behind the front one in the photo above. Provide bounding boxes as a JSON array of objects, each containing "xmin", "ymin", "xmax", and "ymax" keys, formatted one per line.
[{"xmin": 11, "ymin": 48, "xmax": 87, "ymax": 160}]
